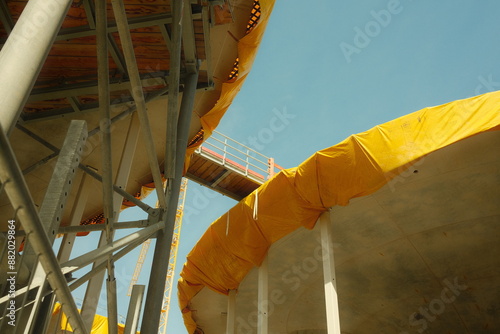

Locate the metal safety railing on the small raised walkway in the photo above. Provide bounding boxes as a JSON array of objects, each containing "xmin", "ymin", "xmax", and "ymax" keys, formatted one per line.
[{"xmin": 195, "ymin": 131, "xmax": 283, "ymax": 183}]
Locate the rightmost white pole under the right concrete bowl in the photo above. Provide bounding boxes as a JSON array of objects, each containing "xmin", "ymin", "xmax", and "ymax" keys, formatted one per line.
[{"xmin": 319, "ymin": 212, "xmax": 340, "ymax": 334}]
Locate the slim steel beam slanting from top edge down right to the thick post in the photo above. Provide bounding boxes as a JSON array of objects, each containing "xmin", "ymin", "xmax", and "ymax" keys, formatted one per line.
[{"xmin": 111, "ymin": 0, "xmax": 167, "ymax": 208}]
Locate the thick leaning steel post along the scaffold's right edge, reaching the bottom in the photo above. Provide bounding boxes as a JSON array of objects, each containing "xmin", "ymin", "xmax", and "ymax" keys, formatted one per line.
[{"xmin": 141, "ymin": 66, "xmax": 198, "ymax": 333}]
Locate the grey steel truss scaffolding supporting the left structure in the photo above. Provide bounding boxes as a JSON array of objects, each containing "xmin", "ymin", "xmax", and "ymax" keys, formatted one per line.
[{"xmin": 0, "ymin": 0, "xmax": 203, "ymax": 334}]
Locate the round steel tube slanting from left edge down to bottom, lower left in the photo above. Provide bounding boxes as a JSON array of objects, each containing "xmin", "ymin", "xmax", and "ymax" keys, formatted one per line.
[{"xmin": 0, "ymin": 123, "xmax": 88, "ymax": 334}]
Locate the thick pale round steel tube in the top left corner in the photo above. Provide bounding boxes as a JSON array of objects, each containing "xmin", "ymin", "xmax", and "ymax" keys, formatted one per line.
[{"xmin": 0, "ymin": 0, "xmax": 73, "ymax": 135}]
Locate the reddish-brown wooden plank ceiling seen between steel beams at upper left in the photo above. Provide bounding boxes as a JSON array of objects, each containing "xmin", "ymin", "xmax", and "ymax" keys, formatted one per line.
[{"xmin": 0, "ymin": 0, "xmax": 208, "ymax": 120}]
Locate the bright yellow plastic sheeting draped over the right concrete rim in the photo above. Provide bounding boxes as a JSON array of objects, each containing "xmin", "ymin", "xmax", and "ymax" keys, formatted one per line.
[{"xmin": 178, "ymin": 92, "xmax": 500, "ymax": 333}]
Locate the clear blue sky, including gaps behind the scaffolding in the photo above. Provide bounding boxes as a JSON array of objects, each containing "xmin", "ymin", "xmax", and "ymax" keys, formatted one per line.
[{"xmin": 67, "ymin": 0, "xmax": 500, "ymax": 333}]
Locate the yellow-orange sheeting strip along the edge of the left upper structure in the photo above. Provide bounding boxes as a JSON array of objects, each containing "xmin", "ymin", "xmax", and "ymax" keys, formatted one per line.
[{"xmin": 184, "ymin": 0, "xmax": 275, "ymax": 172}]
